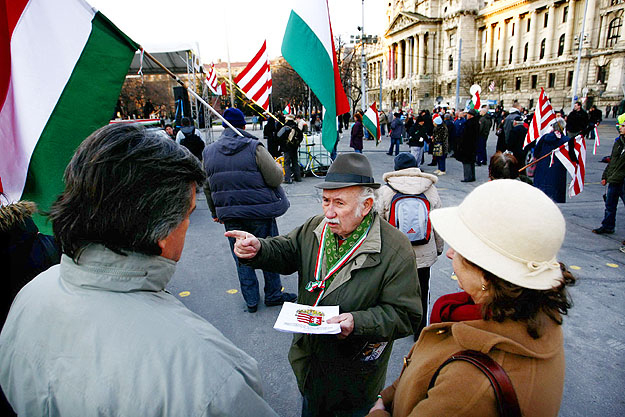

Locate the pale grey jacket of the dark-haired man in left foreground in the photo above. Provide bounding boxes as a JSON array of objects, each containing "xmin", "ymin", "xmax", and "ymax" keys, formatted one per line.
[{"xmin": 0, "ymin": 244, "xmax": 277, "ymax": 417}]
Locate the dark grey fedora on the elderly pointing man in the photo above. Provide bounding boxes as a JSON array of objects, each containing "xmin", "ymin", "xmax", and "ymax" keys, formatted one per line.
[{"xmin": 315, "ymin": 152, "xmax": 380, "ymax": 190}]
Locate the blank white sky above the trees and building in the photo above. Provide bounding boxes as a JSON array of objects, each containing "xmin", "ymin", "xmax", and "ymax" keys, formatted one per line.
[{"xmin": 87, "ymin": 0, "xmax": 388, "ymax": 64}]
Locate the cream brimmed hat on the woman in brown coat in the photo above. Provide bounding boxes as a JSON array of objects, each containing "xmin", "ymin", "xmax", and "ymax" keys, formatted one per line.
[{"xmin": 430, "ymin": 179, "xmax": 566, "ymax": 290}]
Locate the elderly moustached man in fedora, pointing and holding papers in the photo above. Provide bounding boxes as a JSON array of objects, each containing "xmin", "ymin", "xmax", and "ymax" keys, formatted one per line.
[{"xmin": 226, "ymin": 153, "xmax": 421, "ymax": 416}]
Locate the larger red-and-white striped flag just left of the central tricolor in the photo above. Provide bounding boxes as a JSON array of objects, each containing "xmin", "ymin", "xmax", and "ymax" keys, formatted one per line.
[{"xmin": 234, "ymin": 41, "xmax": 271, "ymax": 110}]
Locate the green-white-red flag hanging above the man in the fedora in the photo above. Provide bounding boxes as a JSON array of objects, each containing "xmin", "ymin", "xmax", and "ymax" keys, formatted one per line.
[{"xmin": 282, "ymin": 0, "xmax": 349, "ymax": 152}]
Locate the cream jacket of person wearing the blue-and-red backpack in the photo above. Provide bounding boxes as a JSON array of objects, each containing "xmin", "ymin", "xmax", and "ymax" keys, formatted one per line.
[{"xmin": 378, "ymin": 168, "xmax": 445, "ymax": 268}]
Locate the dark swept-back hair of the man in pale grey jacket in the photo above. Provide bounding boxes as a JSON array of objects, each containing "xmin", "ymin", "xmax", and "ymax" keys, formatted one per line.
[{"xmin": 49, "ymin": 124, "xmax": 205, "ymax": 260}]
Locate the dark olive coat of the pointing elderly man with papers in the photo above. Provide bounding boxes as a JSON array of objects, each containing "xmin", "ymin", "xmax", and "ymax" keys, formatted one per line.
[{"xmin": 245, "ymin": 215, "xmax": 421, "ymax": 409}]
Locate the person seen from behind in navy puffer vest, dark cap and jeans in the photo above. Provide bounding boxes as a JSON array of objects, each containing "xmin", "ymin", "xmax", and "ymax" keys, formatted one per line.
[{"xmin": 203, "ymin": 108, "xmax": 297, "ymax": 313}]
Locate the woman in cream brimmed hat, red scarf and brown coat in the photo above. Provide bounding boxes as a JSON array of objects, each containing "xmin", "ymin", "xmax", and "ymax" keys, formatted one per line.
[{"xmin": 370, "ymin": 179, "xmax": 575, "ymax": 417}]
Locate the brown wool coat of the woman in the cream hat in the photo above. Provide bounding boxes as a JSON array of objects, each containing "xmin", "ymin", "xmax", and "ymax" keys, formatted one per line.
[{"xmin": 369, "ymin": 319, "xmax": 564, "ymax": 417}]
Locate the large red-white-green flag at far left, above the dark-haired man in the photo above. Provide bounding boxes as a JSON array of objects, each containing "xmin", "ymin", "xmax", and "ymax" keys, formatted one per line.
[{"xmin": 0, "ymin": 0, "xmax": 138, "ymax": 233}]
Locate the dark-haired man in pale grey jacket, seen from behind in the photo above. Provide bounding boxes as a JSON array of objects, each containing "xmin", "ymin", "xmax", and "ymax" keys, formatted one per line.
[{"xmin": 0, "ymin": 124, "xmax": 276, "ymax": 416}]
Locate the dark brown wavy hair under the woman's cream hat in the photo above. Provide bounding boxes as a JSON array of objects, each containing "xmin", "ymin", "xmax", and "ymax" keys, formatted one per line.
[{"xmin": 463, "ymin": 258, "xmax": 575, "ymax": 339}]
